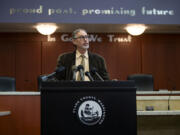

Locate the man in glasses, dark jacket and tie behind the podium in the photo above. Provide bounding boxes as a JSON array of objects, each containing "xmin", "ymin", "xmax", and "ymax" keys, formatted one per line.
[{"xmin": 55, "ymin": 29, "xmax": 109, "ymax": 81}]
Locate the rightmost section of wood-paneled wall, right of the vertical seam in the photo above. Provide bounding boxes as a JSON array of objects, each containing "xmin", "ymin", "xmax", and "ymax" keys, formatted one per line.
[{"xmin": 141, "ymin": 34, "xmax": 180, "ymax": 90}]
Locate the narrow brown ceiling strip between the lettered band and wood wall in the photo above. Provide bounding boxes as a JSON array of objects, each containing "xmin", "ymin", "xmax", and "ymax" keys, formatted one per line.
[{"xmin": 0, "ymin": 23, "xmax": 180, "ymax": 33}]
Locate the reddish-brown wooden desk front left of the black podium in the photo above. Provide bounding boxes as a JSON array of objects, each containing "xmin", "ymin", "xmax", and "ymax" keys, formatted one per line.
[{"xmin": 0, "ymin": 95, "xmax": 41, "ymax": 135}]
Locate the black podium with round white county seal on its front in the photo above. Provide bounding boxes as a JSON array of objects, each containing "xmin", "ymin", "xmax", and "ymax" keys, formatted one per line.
[{"xmin": 41, "ymin": 81, "xmax": 137, "ymax": 135}]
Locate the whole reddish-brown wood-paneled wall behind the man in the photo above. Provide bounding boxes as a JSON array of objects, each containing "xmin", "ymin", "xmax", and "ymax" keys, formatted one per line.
[{"xmin": 0, "ymin": 33, "xmax": 180, "ymax": 91}]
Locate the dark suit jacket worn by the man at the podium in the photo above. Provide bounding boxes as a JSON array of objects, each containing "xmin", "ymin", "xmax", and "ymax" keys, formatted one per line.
[{"xmin": 56, "ymin": 52, "xmax": 109, "ymax": 80}]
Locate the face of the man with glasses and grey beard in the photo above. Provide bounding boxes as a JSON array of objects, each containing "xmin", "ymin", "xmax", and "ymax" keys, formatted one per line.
[{"xmin": 73, "ymin": 30, "xmax": 89, "ymax": 50}]
